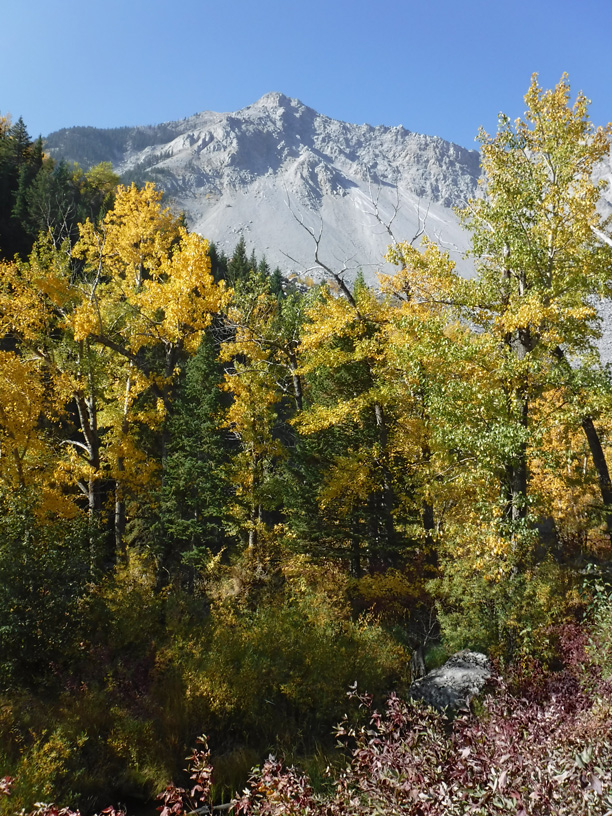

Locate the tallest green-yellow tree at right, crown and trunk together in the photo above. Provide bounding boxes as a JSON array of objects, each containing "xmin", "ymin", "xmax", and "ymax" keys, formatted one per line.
[{"xmin": 462, "ymin": 75, "xmax": 612, "ymax": 544}]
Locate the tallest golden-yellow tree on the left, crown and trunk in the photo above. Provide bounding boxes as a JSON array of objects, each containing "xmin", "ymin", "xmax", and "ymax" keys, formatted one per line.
[{"xmin": 70, "ymin": 184, "xmax": 228, "ymax": 544}]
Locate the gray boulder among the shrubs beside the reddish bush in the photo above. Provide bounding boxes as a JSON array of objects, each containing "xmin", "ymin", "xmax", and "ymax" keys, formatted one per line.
[{"xmin": 410, "ymin": 649, "xmax": 491, "ymax": 709}]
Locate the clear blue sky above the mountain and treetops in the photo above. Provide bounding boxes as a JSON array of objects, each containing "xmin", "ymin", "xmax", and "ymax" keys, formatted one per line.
[{"xmin": 0, "ymin": 0, "xmax": 612, "ymax": 147}]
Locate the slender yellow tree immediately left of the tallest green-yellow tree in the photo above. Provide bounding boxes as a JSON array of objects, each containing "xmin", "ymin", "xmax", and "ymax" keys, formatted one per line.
[{"xmin": 380, "ymin": 238, "xmax": 474, "ymax": 545}]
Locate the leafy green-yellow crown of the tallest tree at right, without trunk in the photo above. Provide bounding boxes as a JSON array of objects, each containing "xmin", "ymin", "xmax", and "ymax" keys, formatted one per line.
[{"xmin": 460, "ymin": 75, "xmax": 612, "ymax": 351}]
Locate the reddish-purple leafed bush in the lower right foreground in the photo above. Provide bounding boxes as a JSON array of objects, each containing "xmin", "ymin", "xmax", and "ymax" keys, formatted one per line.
[{"xmin": 236, "ymin": 627, "xmax": 612, "ymax": 816}]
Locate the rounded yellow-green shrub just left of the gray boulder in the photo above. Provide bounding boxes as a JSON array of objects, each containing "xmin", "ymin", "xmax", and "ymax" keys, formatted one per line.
[{"xmin": 158, "ymin": 558, "xmax": 409, "ymax": 753}]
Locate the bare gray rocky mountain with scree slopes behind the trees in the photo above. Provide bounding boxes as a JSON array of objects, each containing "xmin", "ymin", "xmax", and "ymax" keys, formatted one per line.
[{"xmin": 45, "ymin": 93, "xmax": 480, "ymax": 280}]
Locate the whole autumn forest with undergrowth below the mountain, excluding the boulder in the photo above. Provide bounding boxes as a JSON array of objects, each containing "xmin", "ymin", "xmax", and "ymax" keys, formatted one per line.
[{"xmin": 0, "ymin": 77, "xmax": 612, "ymax": 816}]
